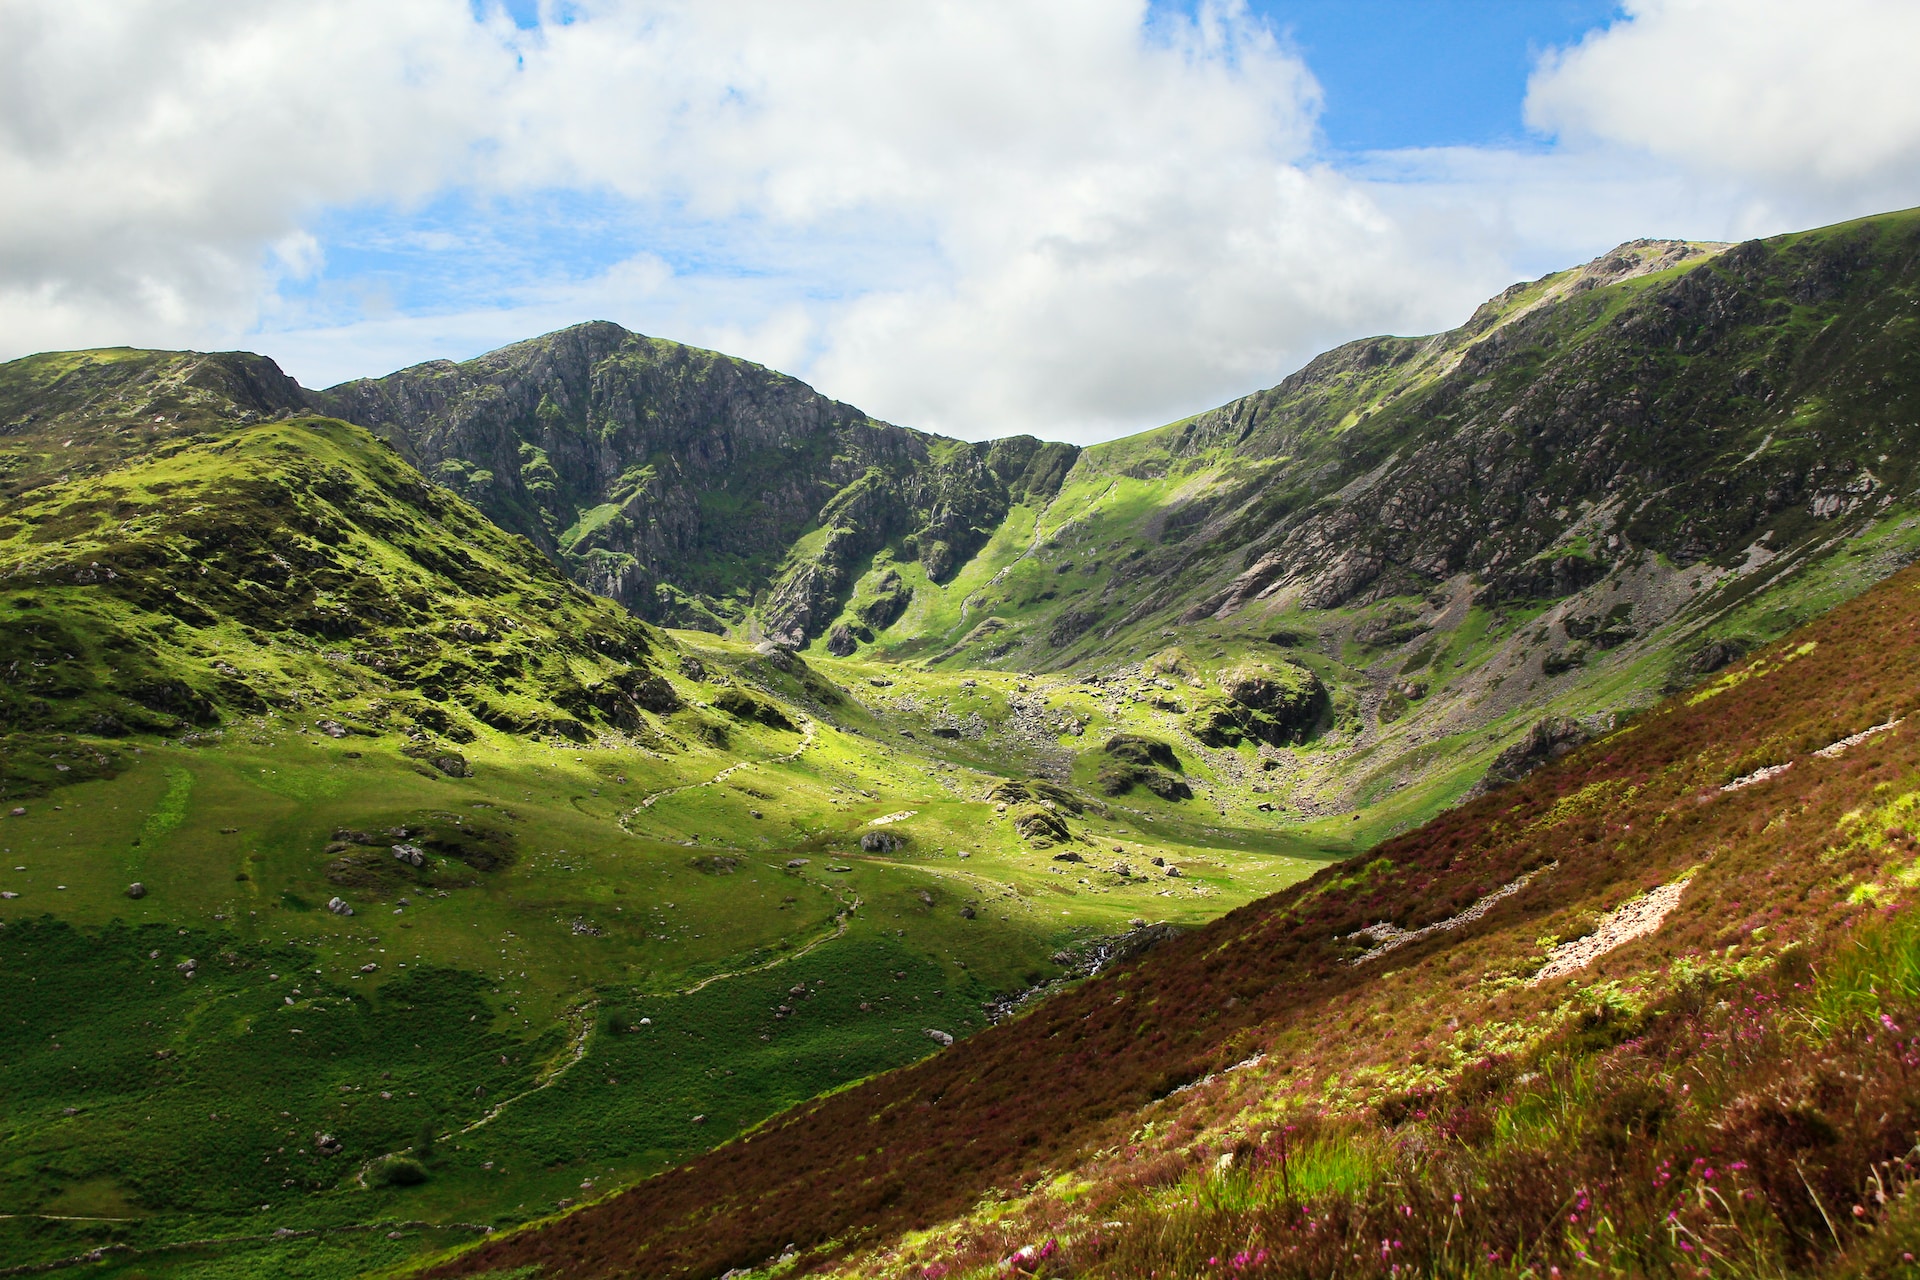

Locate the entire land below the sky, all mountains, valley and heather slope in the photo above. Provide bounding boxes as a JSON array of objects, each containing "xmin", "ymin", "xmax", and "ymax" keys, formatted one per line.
[{"xmin": 0, "ymin": 213, "xmax": 1920, "ymax": 1280}]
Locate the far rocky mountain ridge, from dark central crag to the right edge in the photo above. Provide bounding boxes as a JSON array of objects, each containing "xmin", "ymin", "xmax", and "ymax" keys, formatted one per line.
[{"xmin": 321, "ymin": 213, "xmax": 1920, "ymax": 821}]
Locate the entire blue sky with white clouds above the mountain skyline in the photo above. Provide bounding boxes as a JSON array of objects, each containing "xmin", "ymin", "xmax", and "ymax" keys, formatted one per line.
[{"xmin": 0, "ymin": 0, "xmax": 1920, "ymax": 439}]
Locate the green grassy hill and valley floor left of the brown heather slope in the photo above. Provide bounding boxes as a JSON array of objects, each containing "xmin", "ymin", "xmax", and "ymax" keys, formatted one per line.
[{"xmin": 0, "ymin": 351, "xmax": 1329, "ymax": 1276}]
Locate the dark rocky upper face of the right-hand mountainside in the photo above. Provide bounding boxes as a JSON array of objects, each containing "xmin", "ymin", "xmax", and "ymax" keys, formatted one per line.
[{"xmin": 1121, "ymin": 219, "xmax": 1920, "ymax": 640}]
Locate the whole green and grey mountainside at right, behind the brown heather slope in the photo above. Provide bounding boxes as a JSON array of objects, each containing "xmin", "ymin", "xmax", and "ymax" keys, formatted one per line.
[{"xmin": 817, "ymin": 213, "xmax": 1920, "ymax": 818}]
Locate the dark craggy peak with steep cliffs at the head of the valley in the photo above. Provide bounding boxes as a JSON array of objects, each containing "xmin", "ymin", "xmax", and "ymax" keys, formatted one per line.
[{"xmin": 311, "ymin": 322, "xmax": 1075, "ymax": 643}]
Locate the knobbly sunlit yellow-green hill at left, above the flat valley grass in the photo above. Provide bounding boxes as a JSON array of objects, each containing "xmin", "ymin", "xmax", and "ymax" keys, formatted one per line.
[{"xmin": 0, "ymin": 351, "xmax": 678, "ymax": 768}]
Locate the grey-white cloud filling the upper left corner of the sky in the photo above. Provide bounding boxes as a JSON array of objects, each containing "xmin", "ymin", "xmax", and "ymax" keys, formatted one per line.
[{"xmin": 0, "ymin": 0, "xmax": 513, "ymax": 351}]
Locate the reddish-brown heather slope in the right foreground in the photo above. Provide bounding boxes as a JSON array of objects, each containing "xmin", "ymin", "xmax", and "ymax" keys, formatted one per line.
[{"xmin": 432, "ymin": 570, "xmax": 1920, "ymax": 1276}]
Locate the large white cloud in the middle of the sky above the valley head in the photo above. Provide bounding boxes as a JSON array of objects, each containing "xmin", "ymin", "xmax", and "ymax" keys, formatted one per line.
[{"xmin": 480, "ymin": 0, "xmax": 1498, "ymax": 438}]
